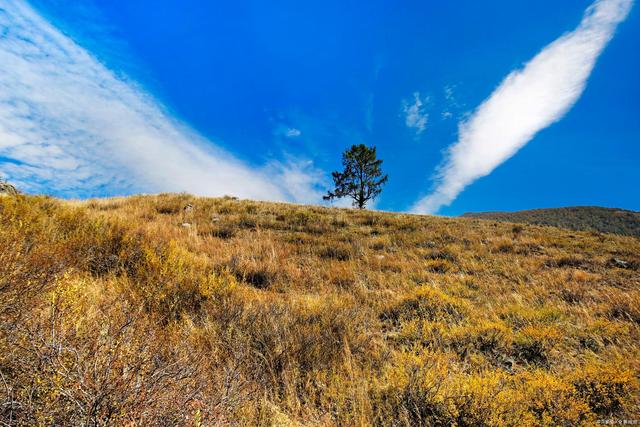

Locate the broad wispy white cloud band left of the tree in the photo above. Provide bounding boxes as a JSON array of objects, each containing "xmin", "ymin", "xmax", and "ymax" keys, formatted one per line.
[{"xmin": 0, "ymin": 0, "xmax": 315, "ymax": 201}]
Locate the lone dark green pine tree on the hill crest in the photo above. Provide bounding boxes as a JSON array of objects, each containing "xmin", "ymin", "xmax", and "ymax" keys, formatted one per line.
[{"xmin": 324, "ymin": 144, "xmax": 389, "ymax": 209}]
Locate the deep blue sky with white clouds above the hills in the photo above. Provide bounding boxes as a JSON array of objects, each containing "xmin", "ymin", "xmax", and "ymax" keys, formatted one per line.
[{"xmin": 0, "ymin": 0, "xmax": 640, "ymax": 215}]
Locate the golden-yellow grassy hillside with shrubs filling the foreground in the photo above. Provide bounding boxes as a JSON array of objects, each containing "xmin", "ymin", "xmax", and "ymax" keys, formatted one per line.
[{"xmin": 0, "ymin": 195, "xmax": 640, "ymax": 426}]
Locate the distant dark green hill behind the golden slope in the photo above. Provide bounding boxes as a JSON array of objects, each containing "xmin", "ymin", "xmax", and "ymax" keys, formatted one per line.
[{"xmin": 462, "ymin": 206, "xmax": 640, "ymax": 237}]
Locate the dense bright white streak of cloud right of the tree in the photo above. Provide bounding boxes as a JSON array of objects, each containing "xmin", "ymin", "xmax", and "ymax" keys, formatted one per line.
[{"xmin": 413, "ymin": 0, "xmax": 633, "ymax": 213}]
